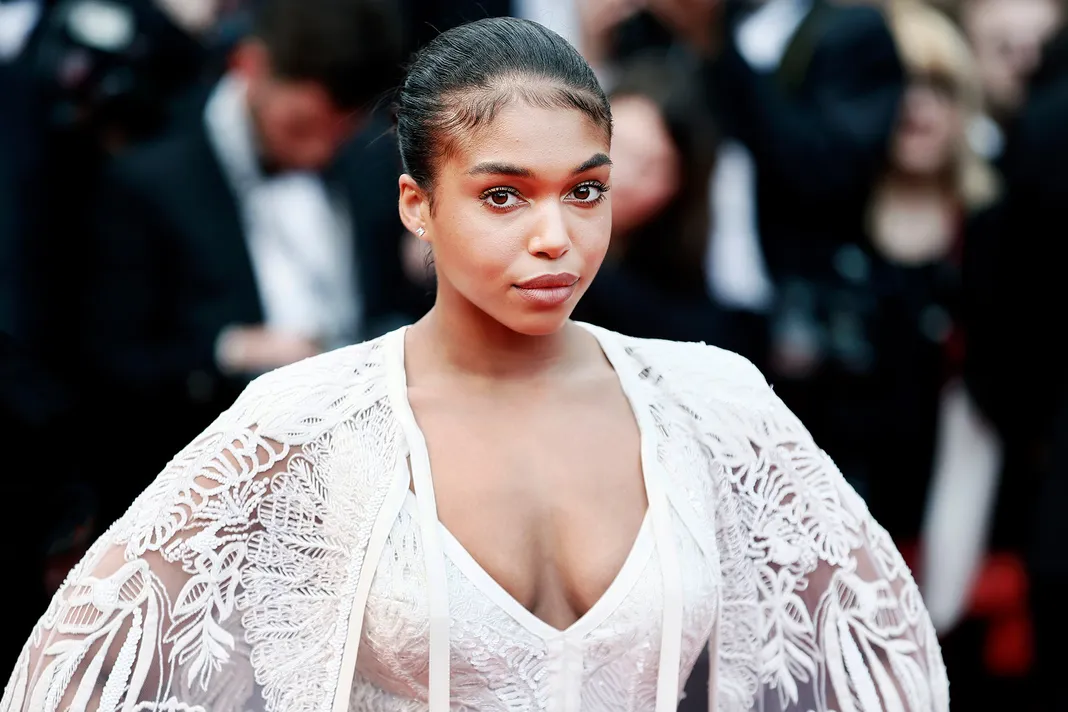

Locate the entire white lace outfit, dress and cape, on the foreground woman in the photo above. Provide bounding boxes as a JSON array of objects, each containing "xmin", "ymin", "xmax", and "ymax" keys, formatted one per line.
[{"xmin": 0, "ymin": 327, "xmax": 948, "ymax": 712}]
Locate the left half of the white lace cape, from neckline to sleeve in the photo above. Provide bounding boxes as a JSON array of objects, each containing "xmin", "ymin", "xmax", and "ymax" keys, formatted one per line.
[{"xmin": 0, "ymin": 342, "xmax": 397, "ymax": 712}]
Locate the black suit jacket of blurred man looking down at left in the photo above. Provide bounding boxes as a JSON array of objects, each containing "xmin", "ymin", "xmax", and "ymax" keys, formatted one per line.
[{"xmin": 85, "ymin": 113, "xmax": 420, "ymax": 411}]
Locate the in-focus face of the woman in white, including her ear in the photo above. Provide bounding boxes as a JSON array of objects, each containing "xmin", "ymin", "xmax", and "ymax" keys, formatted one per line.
[{"xmin": 401, "ymin": 101, "xmax": 612, "ymax": 335}]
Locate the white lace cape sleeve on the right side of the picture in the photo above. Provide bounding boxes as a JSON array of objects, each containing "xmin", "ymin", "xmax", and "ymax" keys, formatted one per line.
[{"xmin": 706, "ymin": 352, "xmax": 948, "ymax": 712}]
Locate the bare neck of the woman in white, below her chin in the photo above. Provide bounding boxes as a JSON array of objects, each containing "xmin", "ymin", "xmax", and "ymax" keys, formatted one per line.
[{"xmin": 410, "ymin": 282, "xmax": 579, "ymax": 381}]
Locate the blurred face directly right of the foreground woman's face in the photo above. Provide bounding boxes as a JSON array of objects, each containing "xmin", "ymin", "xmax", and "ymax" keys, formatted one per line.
[{"xmin": 612, "ymin": 96, "xmax": 681, "ymax": 235}]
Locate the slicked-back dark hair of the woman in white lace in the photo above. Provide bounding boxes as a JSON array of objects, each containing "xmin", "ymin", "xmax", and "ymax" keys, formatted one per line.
[{"xmin": 394, "ymin": 17, "xmax": 612, "ymax": 190}]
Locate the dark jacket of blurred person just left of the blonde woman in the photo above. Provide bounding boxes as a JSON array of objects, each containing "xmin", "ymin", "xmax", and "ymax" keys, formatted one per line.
[{"xmin": 707, "ymin": 0, "xmax": 905, "ymax": 278}]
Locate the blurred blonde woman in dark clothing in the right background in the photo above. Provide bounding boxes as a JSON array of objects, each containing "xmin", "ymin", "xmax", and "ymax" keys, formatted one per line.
[{"xmin": 776, "ymin": 0, "xmax": 994, "ymax": 544}]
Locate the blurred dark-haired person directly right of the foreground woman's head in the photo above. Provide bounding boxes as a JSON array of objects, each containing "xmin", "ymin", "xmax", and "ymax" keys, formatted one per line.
[{"xmin": 576, "ymin": 51, "xmax": 734, "ymax": 347}]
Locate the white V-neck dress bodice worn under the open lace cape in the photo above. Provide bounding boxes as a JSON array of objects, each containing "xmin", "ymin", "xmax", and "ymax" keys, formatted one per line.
[{"xmin": 349, "ymin": 331, "xmax": 718, "ymax": 712}]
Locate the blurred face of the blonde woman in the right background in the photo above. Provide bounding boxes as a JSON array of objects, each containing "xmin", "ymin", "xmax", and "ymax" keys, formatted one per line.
[{"xmin": 893, "ymin": 78, "xmax": 964, "ymax": 177}]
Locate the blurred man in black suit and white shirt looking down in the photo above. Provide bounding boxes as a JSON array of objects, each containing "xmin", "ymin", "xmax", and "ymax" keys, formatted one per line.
[{"xmin": 85, "ymin": 0, "xmax": 415, "ymax": 529}]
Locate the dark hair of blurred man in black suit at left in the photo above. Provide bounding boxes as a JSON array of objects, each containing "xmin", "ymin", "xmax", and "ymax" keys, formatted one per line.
[{"xmin": 252, "ymin": 0, "xmax": 404, "ymax": 109}]
